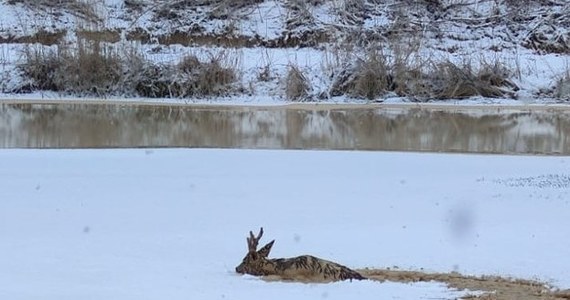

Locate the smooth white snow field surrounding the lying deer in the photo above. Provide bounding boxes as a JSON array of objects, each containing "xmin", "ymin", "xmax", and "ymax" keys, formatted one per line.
[{"xmin": 0, "ymin": 149, "xmax": 570, "ymax": 300}]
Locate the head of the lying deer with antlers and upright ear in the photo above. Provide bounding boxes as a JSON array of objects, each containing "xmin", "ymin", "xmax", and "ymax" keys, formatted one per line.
[{"xmin": 236, "ymin": 227, "xmax": 275, "ymax": 276}]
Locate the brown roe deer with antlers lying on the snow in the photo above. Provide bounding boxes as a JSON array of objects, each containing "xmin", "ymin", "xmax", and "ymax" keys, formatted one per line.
[{"xmin": 236, "ymin": 227, "xmax": 366, "ymax": 282}]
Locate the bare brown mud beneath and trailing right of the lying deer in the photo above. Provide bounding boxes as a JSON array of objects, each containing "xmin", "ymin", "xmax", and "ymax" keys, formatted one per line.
[{"xmin": 263, "ymin": 269, "xmax": 570, "ymax": 300}]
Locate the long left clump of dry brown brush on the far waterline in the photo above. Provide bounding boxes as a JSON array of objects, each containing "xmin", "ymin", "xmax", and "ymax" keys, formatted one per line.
[{"xmin": 19, "ymin": 42, "xmax": 237, "ymax": 97}]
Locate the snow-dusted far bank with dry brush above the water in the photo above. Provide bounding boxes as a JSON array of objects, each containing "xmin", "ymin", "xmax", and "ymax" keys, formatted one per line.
[{"xmin": 0, "ymin": 0, "xmax": 570, "ymax": 103}]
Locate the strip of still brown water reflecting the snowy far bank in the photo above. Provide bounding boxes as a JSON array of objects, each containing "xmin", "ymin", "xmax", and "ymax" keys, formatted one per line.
[{"xmin": 0, "ymin": 103, "xmax": 570, "ymax": 155}]
